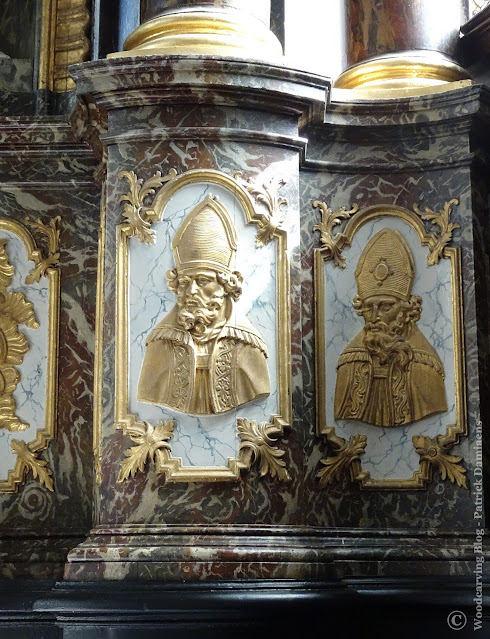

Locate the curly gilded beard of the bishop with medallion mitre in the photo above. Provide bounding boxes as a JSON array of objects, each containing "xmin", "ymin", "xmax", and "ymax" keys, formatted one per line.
[{"xmin": 364, "ymin": 320, "xmax": 413, "ymax": 371}]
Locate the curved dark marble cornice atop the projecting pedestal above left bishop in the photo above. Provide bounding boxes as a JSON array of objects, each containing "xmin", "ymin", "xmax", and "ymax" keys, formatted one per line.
[{"xmin": 70, "ymin": 55, "xmax": 331, "ymax": 122}]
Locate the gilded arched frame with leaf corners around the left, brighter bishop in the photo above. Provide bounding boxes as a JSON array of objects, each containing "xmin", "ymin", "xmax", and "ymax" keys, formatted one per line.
[{"xmin": 115, "ymin": 169, "xmax": 292, "ymax": 482}]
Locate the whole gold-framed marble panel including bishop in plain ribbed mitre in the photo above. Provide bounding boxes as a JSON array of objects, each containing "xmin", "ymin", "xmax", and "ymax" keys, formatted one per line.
[{"xmin": 116, "ymin": 170, "xmax": 291, "ymax": 481}]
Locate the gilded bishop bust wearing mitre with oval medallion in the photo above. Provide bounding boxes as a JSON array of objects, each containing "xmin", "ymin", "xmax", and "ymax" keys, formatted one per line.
[{"xmin": 334, "ymin": 228, "xmax": 447, "ymax": 426}]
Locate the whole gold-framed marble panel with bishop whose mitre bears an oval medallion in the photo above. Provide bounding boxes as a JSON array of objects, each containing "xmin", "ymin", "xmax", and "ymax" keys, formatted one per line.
[{"xmin": 315, "ymin": 201, "xmax": 466, "ymax": 488}]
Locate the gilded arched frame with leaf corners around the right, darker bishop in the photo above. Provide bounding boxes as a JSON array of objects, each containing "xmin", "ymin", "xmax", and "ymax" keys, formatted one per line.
[{"xmin": 314, "ymin": 200, "xmax": 468, "ymax": 490}]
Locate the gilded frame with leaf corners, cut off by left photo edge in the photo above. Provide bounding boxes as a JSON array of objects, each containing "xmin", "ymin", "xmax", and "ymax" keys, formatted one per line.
[{"xmin": 0, "ymin": 218, "xmax": 60, "ymax": 493}]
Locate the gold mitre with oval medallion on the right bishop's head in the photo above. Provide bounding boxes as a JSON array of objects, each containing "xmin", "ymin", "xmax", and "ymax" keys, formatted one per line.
[{"xmin": 355, "ymin": 229, "xmax": 415, "ymax": 301}]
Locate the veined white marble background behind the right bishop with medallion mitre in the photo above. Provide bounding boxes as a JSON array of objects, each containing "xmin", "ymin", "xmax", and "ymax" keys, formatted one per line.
[{"xmin": 324, "ymin": 217, "xmax": 456, "ymax": 479}]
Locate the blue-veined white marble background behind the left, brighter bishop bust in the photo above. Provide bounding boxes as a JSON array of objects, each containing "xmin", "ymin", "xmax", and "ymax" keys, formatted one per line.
[{"xmin": 129, "ymin": 183, "xmax": 279, "ymax": 467}]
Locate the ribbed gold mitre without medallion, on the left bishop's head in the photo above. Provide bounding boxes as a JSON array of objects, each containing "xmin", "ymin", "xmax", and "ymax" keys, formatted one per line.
[{"xmin": 172, "ymin": 195, "xmax": 237, "ymax": 273}]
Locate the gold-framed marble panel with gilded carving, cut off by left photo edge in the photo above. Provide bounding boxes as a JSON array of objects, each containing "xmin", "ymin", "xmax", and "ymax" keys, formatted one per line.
[{"xmin": 0, "ymin": 217, "xmax": 60, "ymax": 492}]
